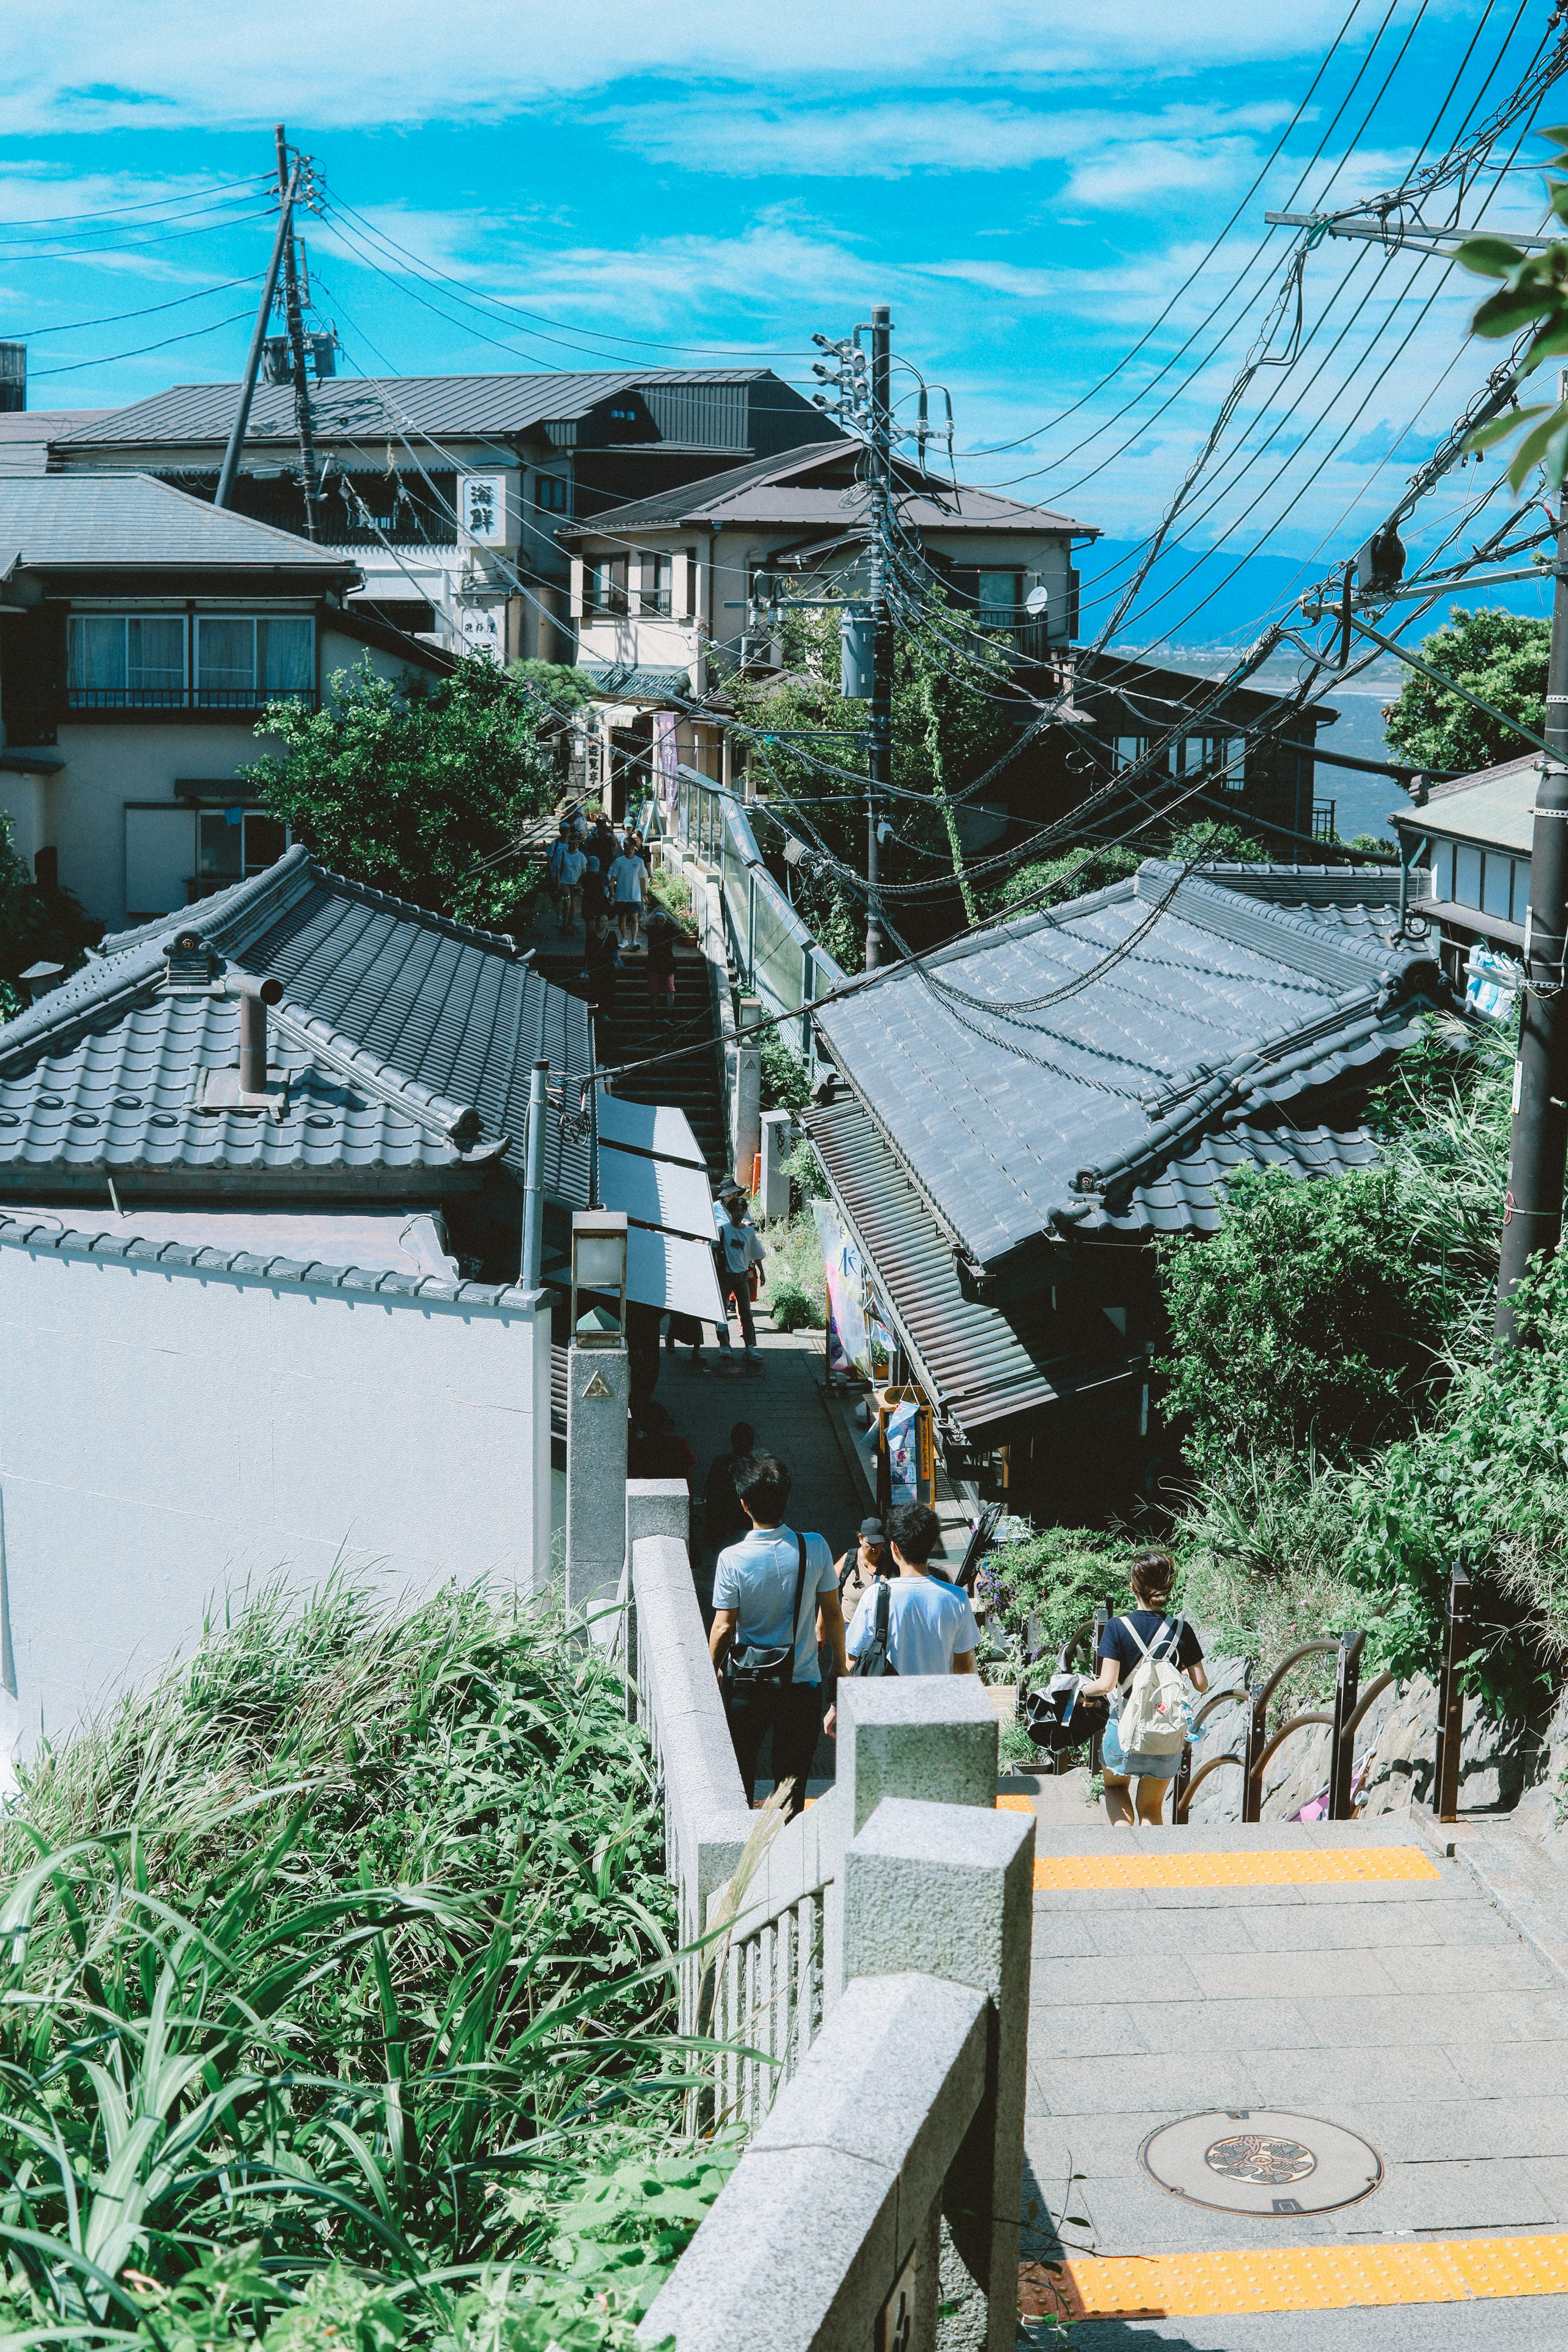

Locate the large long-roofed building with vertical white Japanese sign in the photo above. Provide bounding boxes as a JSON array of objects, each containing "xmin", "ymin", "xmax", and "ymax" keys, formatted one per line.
[{"xmin": 49, "ymin": 367, "xmax": 839, "ymax": 661}]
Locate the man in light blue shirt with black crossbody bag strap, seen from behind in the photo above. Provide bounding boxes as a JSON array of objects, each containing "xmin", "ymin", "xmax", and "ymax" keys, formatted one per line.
[{"xmin": 708, "ymin": 1454, "xmax": 849, "ymax": 1818}]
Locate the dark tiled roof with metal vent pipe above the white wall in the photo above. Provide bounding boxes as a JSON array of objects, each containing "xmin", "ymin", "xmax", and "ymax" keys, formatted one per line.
[{"xmin": 0, "ymin": 847, "xmax": 592, "ymax": 1207}]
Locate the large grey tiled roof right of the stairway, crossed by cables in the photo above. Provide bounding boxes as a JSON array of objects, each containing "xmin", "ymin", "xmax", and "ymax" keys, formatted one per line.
[{"xmin": 816, "ymin": 863, "xmax": 1448, "ymax": 1272}]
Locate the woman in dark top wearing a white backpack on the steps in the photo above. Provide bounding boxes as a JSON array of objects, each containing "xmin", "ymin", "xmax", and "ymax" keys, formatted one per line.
[{"xmin": 1079, "ymin": 1550, "xmax": 1208, "ymax": 1828}]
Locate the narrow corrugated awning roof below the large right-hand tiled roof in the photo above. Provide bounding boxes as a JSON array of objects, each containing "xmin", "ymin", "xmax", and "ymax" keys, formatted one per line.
[{"xmin": 802, "ymin": 1101, "xmax": 1143, "ymax": 1437}]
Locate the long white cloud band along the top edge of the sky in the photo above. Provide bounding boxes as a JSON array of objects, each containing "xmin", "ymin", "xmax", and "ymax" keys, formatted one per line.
[{"xmin": 0, "ymin": 0, "xmax": 1420, "ymax": 132}]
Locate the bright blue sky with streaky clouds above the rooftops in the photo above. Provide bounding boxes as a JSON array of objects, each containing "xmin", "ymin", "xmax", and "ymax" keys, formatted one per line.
[{"xmin": 0, "ymin": 0, "xmax": 1568, "ymax": 635}]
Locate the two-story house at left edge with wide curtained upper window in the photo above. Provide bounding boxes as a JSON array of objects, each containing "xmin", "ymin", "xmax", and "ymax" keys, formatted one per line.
[{"xmin": 0, "ymin": 473, "xmax": 451, "ymax": 929}]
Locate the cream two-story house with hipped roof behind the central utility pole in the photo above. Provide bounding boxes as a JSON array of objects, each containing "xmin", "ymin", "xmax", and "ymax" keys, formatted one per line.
[{"xmin": 559, "ymin": 442, "xmax": 1098, "ymax": 797}]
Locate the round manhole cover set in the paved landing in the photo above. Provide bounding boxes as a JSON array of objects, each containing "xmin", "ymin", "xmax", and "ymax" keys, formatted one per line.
[{"xmin": 1138, "ymin": 2110, "xmax": 1382, "ymax": 2213}]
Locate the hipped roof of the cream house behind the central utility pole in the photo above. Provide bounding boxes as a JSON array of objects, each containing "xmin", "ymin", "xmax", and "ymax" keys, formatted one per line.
[{"xmin": 557, "ymin": 442, "xmax": 1089, "ymax": 543}]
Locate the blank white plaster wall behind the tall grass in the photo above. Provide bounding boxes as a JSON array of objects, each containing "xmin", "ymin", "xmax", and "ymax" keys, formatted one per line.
[{"xmin": 0, "ymin": 1247, "xmax": 550, "ymax": 1750}]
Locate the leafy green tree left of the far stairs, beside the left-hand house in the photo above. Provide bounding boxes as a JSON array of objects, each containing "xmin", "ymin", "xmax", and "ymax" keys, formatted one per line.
[{"xmin": 242, "ymin": 656, "xmax": 559, "ymax": 929}]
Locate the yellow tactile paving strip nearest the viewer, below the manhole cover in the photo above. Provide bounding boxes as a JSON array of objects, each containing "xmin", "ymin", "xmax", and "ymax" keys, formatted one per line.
[{"xmin": 1018, "ymin": 2237, "xmax": 1568, "ymax": 2319}]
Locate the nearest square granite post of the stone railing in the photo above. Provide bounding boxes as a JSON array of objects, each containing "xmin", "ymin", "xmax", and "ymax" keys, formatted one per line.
[{"xmin": 844, "ymin": 1797, "xmax": 1034, "ymax": 2352}]
